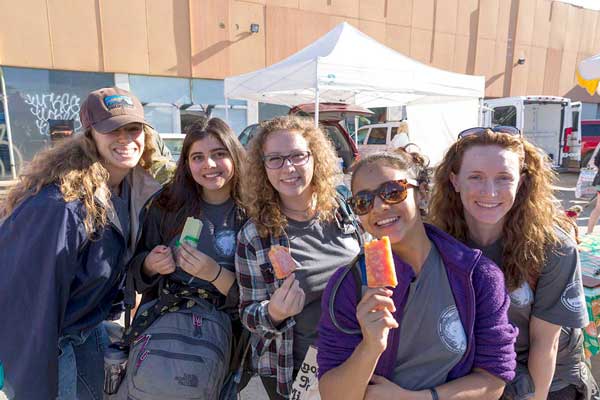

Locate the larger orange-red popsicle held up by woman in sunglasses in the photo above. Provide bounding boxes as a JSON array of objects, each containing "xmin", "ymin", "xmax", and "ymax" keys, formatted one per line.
[{"xmin": 365, "ymin": 236, "xmax": 398, "ymax": 288}]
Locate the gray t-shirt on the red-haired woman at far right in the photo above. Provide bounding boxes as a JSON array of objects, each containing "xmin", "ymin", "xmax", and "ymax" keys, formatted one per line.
[{"xmin": 467, "ymin": 229, "xmax": 589, "ymax": 392}]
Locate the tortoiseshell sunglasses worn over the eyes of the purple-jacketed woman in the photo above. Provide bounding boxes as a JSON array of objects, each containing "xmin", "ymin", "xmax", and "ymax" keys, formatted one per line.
[{"xmin": 348, "ymin": 179, "xmax": 419, "ymax": 215}]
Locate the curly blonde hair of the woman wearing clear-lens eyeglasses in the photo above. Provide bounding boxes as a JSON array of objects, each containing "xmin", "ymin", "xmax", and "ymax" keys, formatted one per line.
[{"xmin": 243, "ymin": 116, "xmax": 341, "ymax": 237}]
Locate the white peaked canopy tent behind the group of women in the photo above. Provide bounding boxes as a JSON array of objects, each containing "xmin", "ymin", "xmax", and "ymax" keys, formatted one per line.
[{"xmin": 225, "ymin": 22, "xmax": 485, "ymax": 166}]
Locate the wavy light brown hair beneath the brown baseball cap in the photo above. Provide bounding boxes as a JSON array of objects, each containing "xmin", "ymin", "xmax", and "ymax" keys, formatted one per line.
[{"xmin": 0, "ymin": 125, "xmax": 156, "ymax": 237}]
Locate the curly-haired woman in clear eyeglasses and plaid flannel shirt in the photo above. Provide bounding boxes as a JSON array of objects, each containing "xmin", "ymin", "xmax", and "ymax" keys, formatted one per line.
[{"xmin": 235, "ymin": 117, "xmax": 359, "ymax": 399}]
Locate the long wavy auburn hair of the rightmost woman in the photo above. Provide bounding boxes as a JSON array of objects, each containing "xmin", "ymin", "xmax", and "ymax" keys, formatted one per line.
[{"xmin": 429, "ymin": 129, "xmax": 571, "ymax": 290}]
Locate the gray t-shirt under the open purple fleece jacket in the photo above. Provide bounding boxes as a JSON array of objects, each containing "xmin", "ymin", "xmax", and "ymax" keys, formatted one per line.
[{"xmin": 393, "ymin": 243, "xmax": 467, "ymax": 390}]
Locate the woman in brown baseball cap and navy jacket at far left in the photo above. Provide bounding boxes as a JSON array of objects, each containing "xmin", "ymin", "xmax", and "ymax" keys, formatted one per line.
[{"xmin": 0, "ymin": 88, "xmax": 160, "ymax": 400}]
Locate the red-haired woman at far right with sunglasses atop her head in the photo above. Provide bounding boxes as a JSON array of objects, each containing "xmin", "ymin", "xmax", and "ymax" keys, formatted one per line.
[{"xmin": 430, "ymin": 127, "xmax": 599, "ymax": 399}]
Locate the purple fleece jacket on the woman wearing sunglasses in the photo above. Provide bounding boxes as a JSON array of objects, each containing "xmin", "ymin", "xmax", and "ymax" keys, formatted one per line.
[{"xmin": 317, "ymin": 224, "xmax": 517, "ymax": 381}]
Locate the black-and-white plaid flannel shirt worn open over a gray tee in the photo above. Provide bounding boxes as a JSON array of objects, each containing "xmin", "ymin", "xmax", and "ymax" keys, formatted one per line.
[{"xmin": 235, "ymin": 221, "xmax": 296, "ymax": 396}]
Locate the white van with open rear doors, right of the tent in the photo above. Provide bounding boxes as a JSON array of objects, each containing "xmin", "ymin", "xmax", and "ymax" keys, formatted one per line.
[{"xmin": 482, "ymin": 96, "xmax": 581, "ymax": 168}]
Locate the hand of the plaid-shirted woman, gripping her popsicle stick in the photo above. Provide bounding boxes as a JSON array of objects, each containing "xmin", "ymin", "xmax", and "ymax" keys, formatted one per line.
[{"xmin": 267, "ymin": 274, "xmax": 305, "ymax": 325}]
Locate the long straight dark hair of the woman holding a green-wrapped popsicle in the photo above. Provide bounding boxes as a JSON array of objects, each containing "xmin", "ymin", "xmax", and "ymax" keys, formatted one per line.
[{"xmin": 156, "ymin": 118, "xmax": 246, "ymax": 237}]
